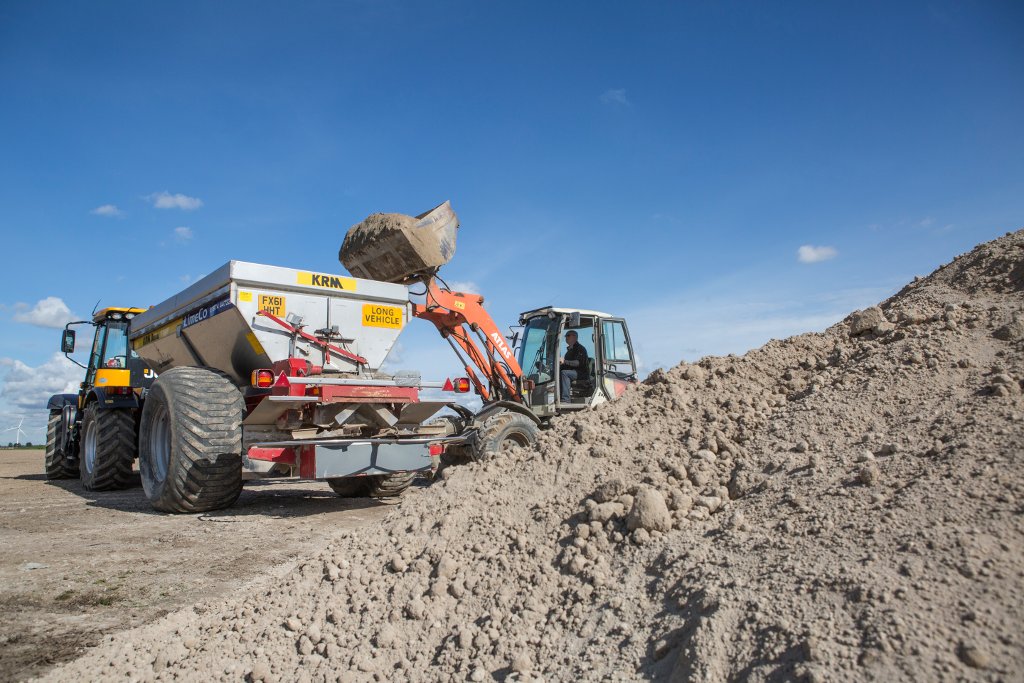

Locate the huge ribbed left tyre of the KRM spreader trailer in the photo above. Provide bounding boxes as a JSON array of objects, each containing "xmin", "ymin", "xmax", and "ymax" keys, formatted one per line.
[{"xmin": 138, "ymin": 368, "xmax": 245, "ymax": 512}]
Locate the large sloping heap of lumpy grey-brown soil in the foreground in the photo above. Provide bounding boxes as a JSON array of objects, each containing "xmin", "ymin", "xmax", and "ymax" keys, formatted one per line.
[{"xmin": 39, "ymin": 231, "xmax": 1024, "ymax": 681}]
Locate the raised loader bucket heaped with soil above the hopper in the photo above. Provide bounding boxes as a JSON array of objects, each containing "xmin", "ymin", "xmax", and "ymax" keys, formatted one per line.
[{"xmin": 338, "ymin": 202, "xmax": 459, "ymax": 283}]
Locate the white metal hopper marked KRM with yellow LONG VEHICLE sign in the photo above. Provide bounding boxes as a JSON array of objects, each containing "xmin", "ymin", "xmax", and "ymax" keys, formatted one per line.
[{"xmin": 129, "ymin": 261, "xmax": 411, "ymax": 386}]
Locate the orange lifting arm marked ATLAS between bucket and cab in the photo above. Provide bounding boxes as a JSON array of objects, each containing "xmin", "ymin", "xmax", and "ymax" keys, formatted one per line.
[{"xmin": 413, "ymin": 280, "xmax": 522, "ymax": 402}]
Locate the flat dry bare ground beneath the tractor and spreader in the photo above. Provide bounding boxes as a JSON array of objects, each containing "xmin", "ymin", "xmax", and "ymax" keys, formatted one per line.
[{"xmin": 0, "ymin": 451, "xmax": 386, "ymax": 681}]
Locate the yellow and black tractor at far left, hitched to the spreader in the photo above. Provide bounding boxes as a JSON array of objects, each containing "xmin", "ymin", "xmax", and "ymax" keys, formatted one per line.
[{"xmin": 46, "ymin": 306, "xmax": 157, "ymax": 490}]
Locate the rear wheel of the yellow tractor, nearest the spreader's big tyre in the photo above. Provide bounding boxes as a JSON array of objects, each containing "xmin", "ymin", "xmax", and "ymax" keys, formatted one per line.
[{"xmin": 78, "ymin": 402, "xmax": 136, "ymax": 490}]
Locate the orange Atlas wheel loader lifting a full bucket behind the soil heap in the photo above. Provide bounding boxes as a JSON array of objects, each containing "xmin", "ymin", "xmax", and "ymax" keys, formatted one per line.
[{"xmin": 338, "ymin": 202, "xmax": 637, "ymax": 458}]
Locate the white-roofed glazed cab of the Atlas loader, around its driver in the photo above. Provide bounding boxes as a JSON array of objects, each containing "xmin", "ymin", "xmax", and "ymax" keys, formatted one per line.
[{"xmin": 518, "ymin": 306, "xmax": 637, "ymax": 418}]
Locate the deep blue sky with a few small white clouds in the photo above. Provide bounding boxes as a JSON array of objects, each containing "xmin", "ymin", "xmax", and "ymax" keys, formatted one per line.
[{"xmin": 0, "ymin": 1, "xmax": 1024, "ymax": 440}]
